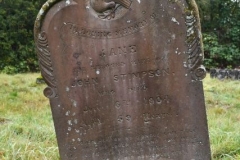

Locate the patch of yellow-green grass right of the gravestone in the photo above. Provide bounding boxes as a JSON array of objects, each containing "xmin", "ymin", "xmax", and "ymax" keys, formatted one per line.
[{"xmin": 204, "ymin": 74, "xmax": 240, "ymax": 160}]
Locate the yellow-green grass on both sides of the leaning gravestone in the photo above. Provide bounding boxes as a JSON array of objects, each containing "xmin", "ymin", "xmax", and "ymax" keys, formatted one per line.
[{"xmin": 0, "ymin": 74, "xmax": 240, "ymax": 160}]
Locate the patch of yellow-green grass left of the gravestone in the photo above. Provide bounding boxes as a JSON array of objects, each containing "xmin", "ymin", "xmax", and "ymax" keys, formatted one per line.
[{"xmin": 0, "ymin": 74, "xmax": 59, "ymax": 160}]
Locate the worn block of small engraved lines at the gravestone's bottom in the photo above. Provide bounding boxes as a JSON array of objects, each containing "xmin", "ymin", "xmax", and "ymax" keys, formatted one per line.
[{"xmin": 79, "ymin": 128, "xmax": 204, "ymax": 160}]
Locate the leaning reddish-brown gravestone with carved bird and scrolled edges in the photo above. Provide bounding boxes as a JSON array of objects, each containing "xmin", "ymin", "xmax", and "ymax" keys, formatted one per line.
[{"xmin": 35, "ymin": 0, "xmax": 210, "ymax": 160}]
